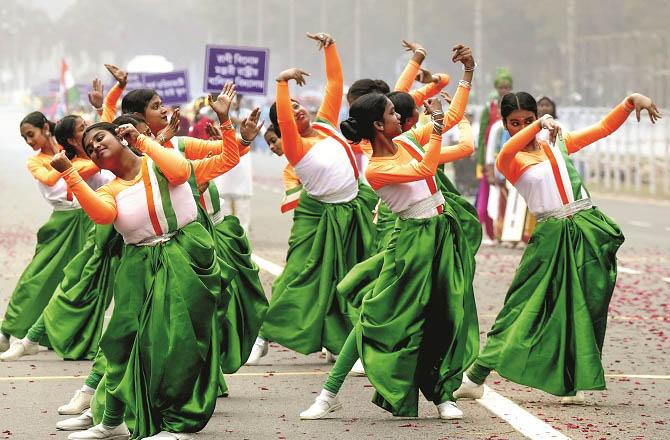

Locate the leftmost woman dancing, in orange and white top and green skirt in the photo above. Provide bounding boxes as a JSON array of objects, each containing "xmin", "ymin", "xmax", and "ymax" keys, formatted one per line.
[{"xmin": 0, "ymin": 112, "xmax": 100, "ymax": 354}]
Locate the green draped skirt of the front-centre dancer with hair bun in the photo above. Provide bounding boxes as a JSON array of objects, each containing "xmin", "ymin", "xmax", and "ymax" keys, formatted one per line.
[{"xmin": 355, "ymin": 205, "xmax": 479, "ymax": 417}]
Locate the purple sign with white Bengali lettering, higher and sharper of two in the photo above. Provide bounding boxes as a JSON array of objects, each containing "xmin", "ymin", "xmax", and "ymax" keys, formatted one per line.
[{"xmin": 203, "ymin": 45, "xmax": 270, "ymax": 95}]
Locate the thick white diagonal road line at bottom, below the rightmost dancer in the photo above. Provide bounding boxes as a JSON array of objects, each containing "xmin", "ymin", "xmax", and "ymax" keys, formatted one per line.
[{"xmin": 477, "ymin": 385, "xmax": 570, "ymax": 440}]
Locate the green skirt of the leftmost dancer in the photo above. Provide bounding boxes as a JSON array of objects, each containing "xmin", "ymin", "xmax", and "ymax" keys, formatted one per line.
[{"xmin": 1, "ymin": 209, "xmax": 93, "ymax": 338}]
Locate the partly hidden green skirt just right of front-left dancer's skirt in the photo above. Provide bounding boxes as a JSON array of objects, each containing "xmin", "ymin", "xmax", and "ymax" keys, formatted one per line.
[{"xmin": 212, "ymin": 215, "xmax": 268, "ymax": 374}]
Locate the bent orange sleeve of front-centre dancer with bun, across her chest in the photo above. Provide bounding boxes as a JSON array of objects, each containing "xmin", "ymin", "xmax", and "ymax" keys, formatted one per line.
[{"xmin": 365, "ymin": 134, "xmax": 442, "ymax": 189}]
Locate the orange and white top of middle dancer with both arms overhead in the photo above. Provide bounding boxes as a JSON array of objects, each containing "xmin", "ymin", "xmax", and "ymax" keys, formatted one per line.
[{"xmin": 277, "ymin": 44, "xmax": 359, "ymax": 203}]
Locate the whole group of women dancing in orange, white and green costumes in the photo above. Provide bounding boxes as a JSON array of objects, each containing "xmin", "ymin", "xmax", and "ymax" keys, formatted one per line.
[{"xmin": 0, "ymin": 33, "xmax": 660, "ymax": 440}]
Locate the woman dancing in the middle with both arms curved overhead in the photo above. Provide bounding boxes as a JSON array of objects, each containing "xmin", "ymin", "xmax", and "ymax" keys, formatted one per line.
[{"xmin": 247, "ymin": 33, "xmax": 376, "ymax": 365}]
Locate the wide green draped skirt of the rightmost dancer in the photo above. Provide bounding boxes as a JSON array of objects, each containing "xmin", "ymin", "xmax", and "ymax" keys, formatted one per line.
[{"xmin": 477, "ymin": 208, "xmax": 624, "ymax": 396}]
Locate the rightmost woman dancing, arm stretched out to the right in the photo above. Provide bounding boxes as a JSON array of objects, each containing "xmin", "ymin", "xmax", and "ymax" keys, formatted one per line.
[{"xmin": 454, "ymin": 92, "xmax": 660, "ymax": 402}]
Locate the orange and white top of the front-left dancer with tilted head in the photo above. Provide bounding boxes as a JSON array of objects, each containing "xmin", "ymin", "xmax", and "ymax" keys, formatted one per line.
[{"xmin": 63, "ymin": 135, "xmax": 239, "ymax": 245}]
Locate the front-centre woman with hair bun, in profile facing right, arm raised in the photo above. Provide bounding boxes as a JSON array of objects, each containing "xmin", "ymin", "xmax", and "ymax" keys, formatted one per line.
[{"xmin": 300, "ymin": 45, "xmax": 478, "ymax": 419}]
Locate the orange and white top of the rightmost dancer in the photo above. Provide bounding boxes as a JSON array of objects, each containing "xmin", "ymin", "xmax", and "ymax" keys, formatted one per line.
[{"xmin": 496, "ymin": 99, "xmax": 634, "ymax": 215}]
